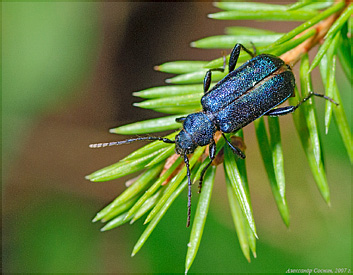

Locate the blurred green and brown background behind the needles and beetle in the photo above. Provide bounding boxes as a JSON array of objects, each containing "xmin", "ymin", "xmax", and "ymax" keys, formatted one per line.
[{"xmin": 2, "ymin": 2, "xmax": 352, "ymax": 273}]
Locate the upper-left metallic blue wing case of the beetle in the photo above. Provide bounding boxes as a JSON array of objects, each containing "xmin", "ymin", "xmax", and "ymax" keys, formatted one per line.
[{"xmin": 201, "ymin": 54, "xmax": 284, "ymax": 113}]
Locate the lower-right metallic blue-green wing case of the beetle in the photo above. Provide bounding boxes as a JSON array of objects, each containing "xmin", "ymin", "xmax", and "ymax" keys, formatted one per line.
[{"xmin": 214, "ymin": 70, "xmax": 295, "ymax": 133}]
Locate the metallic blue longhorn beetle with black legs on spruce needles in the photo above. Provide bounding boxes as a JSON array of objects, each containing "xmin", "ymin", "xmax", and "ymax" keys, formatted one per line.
[{"xmin": 90, "ymin": 44, "xmax": 337, "ymax": 227}]
